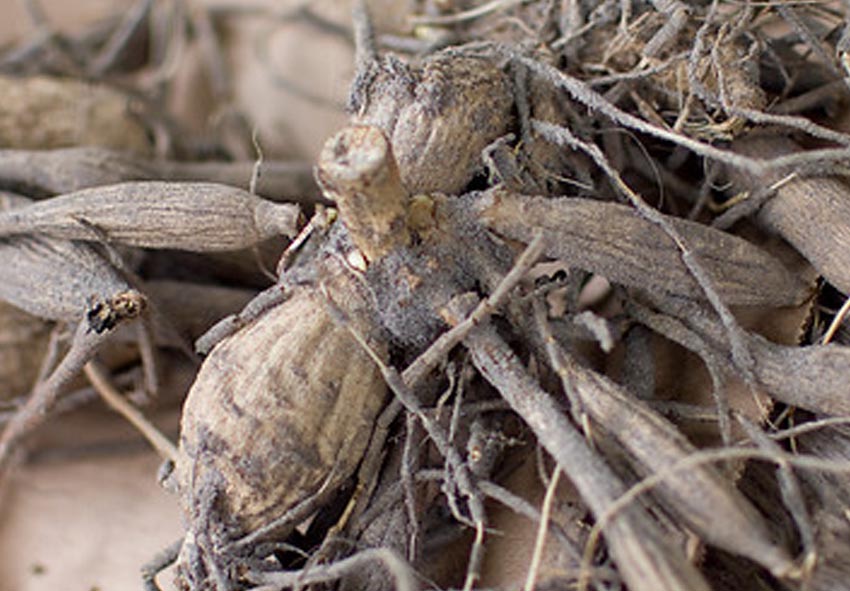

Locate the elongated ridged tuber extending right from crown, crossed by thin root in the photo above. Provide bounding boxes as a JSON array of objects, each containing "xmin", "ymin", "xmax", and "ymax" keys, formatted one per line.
[{"xmin": 474, "ymin": 190, "xmax": 807, "ymax": 306}]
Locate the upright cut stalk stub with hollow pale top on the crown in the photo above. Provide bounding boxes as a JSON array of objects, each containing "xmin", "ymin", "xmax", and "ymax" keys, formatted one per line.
[{"xmin": 317, "ymin": 125, "xmax": 410, "ymax": 261}]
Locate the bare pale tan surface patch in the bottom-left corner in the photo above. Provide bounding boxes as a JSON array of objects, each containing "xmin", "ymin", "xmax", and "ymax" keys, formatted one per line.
[{"xmin": 0, "ymin": 404, "xmax": 182, "ymax": 591}]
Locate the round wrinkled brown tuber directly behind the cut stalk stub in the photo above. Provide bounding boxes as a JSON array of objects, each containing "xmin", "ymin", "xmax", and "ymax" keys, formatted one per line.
[{"xmin": 352, "ymin": 50, "xmax": 514, "ymax": 194}]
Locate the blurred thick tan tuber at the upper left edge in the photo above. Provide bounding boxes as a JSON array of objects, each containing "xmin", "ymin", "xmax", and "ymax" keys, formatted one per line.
[{"xmin": 0, "ymin": 76, "xmax": 151, "ymax": 154}]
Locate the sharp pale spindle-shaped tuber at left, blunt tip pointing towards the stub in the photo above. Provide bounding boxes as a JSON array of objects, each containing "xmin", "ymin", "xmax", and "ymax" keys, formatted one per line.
[{"xmin": 0, "ymin": 182, "xmax": 300, "ymax": 252}]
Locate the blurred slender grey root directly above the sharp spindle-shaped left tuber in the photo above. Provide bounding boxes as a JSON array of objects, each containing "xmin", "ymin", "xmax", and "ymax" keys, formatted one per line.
[{"xmin": 0, "ymin": 147, "xmax": 318, "ymax": 201}]
